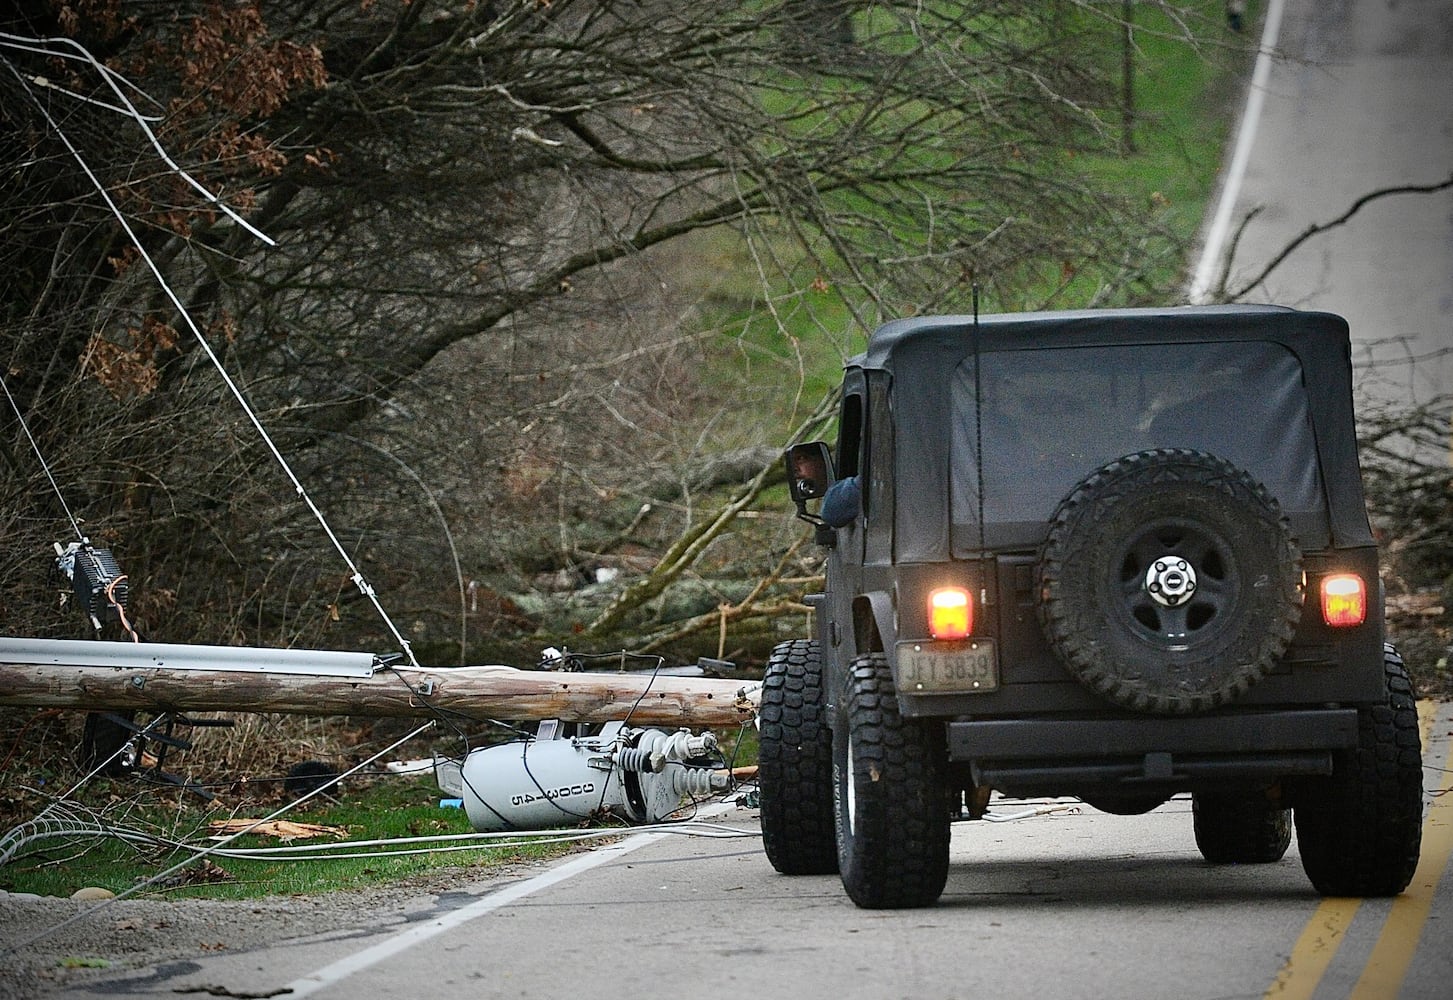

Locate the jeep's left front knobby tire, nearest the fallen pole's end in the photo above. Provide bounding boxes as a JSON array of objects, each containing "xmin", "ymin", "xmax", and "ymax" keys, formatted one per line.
[{"xmin": 757, "ymin": 640, "xmax": 837, "ymax": 875}]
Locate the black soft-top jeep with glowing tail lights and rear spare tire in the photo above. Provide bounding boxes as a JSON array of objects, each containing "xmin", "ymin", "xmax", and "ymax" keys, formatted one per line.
[{"xmin": 758, "ymin": 305, "xmax": 1422, "ymax": 907}]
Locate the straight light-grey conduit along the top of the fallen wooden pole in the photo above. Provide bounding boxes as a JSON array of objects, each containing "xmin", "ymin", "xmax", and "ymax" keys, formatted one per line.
[{"xmin": 0, "ymin": 635, "xmax": 378, "ymax": 677}]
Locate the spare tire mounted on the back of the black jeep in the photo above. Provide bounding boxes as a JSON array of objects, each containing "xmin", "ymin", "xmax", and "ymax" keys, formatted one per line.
[{"xmin": 1039, "ymin": 449, "xmax": 1302, "ymax": 714}]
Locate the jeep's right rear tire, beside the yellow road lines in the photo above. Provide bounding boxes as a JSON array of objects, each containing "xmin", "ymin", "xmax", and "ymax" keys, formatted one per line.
[{"xmin": 1293, "ymin": 645, "xmax": 1422, "ymax": 895}]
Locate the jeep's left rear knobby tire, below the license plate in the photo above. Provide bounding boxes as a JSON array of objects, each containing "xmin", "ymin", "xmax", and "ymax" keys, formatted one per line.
[{"xmin": 833, "ymin": 653, "xmax": 949, "ymax": 910}]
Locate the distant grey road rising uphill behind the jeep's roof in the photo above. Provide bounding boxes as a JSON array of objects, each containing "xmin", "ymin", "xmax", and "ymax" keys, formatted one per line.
[{"xmin": 1193, "ymin": 0, "xmax": 1453, "ymax": 403}]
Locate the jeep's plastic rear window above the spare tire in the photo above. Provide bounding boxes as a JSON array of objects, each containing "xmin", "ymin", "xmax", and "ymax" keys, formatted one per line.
[{"xmin": 950, "ymin": 342, "xmax": 1324, "ymax": 555}]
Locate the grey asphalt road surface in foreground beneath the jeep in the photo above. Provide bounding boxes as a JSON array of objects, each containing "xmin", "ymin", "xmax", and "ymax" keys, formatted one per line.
[{"xmin": 39, "ymin": 703, "xmax": 1453, "ymax": 1000}]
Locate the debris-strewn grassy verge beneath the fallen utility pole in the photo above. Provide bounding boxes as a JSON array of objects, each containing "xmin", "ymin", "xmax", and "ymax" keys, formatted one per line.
[{"xmin": 0, "ymin": 712, "xmax": 757, "ymax": 900}]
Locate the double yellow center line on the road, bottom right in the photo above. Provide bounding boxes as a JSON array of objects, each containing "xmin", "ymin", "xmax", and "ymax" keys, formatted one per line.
[{"xmin": 1264, "ymin": 702, "xmax": 1453, "ymax": 1000}]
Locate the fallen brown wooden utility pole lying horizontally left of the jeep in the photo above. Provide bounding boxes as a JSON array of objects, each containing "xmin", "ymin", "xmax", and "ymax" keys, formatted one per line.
[{"xmin": 0, "ymin": 638, "xmax": 756, "ymax": 727}]
